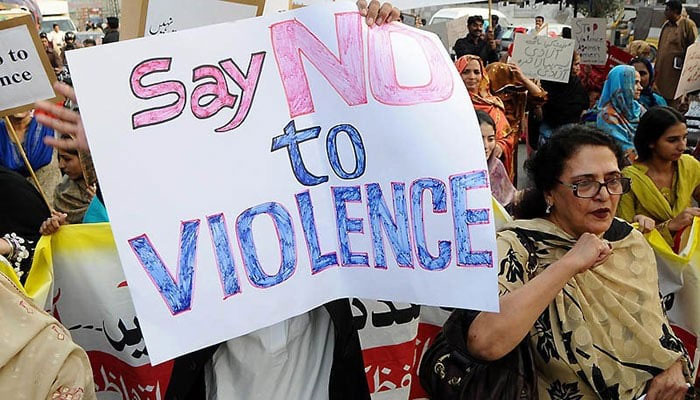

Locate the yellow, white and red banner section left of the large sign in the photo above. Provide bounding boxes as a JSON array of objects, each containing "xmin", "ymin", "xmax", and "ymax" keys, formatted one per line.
[{"xmin": 32, "ymin": 224, "xmax": 173, "ymax": 400}]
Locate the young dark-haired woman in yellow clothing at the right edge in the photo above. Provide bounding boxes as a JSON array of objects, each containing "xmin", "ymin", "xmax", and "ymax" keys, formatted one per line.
[{"xmin": 618, "ymin": 107, "xmax": 700, "ymax": 246}]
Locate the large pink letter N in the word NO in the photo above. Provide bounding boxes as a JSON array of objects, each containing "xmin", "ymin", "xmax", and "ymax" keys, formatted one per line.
[{"xmin": 270, "ymin": 12, "xmax": 366, "ymax": 118}]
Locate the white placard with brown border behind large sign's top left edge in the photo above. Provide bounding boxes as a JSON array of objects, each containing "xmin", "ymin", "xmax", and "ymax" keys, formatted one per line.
[{"xmin": 121, "ymin": 0, "xmax": 268, "ymax": 39}]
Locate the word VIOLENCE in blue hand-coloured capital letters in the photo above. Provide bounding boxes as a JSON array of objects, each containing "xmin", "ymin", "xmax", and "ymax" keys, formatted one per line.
[{"xmin": 128, "ymin": 170, "xmax": 493, "ymax": 315}]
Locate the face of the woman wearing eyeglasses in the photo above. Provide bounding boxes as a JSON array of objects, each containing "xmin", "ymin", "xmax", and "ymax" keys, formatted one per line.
[{"xmin": 545, "ymin": 145, "xmax": 622, "ymax": 238}]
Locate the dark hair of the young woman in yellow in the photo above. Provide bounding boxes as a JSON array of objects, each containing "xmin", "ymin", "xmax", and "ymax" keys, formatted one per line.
[{"xmin": 634, "ymin": 106, "xmax": 685, "ymax": 161}]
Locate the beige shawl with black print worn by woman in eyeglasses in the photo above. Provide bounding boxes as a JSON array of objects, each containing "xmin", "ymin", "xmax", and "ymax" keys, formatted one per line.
[{"xmin": 498, "ymin": 219, "xmax": 692, "ymax": 400}]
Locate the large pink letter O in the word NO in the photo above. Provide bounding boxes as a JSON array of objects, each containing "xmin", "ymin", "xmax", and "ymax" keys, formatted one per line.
[{"xmin": 367, "ymin": 24, "xmax": 454, "ymax": 106}]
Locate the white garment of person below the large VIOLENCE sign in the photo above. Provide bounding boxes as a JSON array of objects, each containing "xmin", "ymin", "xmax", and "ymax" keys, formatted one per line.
[{"xmin": 205, "ymin": 307, "xmax": 335, "ymax": 400}]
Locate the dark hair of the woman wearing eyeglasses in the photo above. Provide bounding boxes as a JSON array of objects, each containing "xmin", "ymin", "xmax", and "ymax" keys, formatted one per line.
[{"xmin": 514, "ymin": 124, "xmax": 624, "ymax": 219}]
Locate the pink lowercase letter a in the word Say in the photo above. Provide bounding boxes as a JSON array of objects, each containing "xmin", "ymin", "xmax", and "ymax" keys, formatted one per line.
[{"xmin": 190, "ymin": 65, "xmax": 237, "ymax": 119}]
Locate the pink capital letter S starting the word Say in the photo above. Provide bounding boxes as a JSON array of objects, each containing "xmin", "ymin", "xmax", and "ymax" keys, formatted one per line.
[{"xmin": 130, "ymin": 58, "xmax": 187, "ymax": 129}]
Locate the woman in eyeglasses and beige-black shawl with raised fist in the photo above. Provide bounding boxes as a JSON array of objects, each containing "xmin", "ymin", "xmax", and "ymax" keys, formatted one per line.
[{"xmin": 456, "ymin": 125, "xmax": 692, "ymax": 400}]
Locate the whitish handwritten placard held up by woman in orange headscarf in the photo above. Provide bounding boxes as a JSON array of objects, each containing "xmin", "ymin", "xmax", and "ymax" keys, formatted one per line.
[{"xmin": 511, "ymin": 33, "xmax": 575, "ymax": 82}]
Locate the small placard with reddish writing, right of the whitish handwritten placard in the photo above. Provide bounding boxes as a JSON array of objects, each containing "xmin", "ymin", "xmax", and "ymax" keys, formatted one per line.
[{"xmin": 571, "ymin": 18, "xmax": 608, "ymax": 65}]
